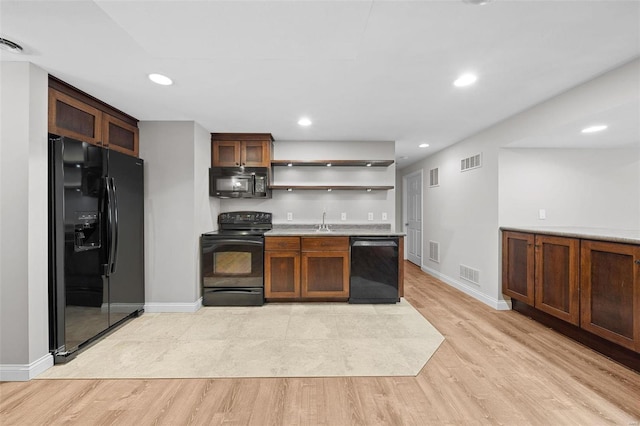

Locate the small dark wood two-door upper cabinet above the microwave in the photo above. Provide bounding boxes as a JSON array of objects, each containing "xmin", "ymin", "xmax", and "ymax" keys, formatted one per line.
[{"xmin": 211, "ymin": 133, "xmax": 273, "ymax": 167}]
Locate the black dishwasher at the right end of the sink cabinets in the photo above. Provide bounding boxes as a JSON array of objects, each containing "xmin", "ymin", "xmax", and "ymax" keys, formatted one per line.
[{"xmin": 349, "ymin": 237, "xmax": 400, "ymax": 303}]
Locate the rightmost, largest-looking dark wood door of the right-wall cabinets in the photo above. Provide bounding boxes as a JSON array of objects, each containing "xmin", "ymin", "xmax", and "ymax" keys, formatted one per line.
[{"xmin": 580, "ymin": 240, "xmax": 640, "ymax": 352}]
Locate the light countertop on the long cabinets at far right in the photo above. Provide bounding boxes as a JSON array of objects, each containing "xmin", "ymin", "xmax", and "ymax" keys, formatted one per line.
[{"xmin": 500, "ymin": 226, "xmax": 640, "ymax": 244}]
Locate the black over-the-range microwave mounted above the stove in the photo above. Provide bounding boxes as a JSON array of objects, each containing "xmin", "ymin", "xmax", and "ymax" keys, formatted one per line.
[{"xmin": 209, "ymin": 167, "xmax": 271, "ymax": 198}]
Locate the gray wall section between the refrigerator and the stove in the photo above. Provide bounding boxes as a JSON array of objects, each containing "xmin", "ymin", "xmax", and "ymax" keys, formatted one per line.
[{"xmin": 139, "ymin": 121, "xmax": 219, "ymax": 312}]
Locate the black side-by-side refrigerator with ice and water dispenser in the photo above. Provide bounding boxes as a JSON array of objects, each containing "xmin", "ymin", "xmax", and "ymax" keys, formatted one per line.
[{"xmin": 49, "ymin": 134, "xmax": 144, "ymax": 364}]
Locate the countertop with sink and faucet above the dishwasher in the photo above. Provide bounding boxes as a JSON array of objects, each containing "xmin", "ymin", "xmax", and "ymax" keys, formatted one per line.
[{"xmin": 264, "ymin": 223, "xmax": 406, "ymax": 237}]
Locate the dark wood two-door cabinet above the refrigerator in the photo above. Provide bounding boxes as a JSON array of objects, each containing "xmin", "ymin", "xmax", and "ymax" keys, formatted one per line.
[{"xmin": 49, "ymin": 76, "xmax": 139, "ymax": 157}]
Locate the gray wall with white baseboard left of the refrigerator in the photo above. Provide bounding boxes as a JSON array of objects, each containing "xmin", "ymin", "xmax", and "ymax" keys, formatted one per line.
[{"xmin": 0, "ymin": 62, "xmax": 52, "ymax": 380}]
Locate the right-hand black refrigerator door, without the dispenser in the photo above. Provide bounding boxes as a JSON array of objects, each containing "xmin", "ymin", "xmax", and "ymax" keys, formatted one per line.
[{"xmin": 107, "ymin": 151, "xmax": 144, "ymax": 325}]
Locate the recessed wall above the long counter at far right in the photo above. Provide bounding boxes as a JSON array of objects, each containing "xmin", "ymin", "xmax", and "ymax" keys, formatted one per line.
[{"xmin": 499, "ymin": 147, "xmax": 640, "ymax": 229}]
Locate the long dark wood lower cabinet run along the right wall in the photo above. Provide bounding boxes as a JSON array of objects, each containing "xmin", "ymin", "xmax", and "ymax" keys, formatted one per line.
[{"xmin": 502, "ymin": 231, "xmax": 640, "ymax": 370}]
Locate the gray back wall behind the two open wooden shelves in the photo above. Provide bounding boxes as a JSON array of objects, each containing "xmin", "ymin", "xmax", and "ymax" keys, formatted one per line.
[{"xmin": 220, "ymin": 141, "xmax": 396, "ymax": 228}]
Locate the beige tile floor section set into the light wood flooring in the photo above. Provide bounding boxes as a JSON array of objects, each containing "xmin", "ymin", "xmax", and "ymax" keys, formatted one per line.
[{"xmin": 38, "ymin": 299, "xmax": 444, "ymax": 379}]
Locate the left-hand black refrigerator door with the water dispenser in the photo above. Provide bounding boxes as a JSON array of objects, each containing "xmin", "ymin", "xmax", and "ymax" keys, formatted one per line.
[{"xmin": 49, "ymin": 136, "xmax": 109, "ymax": 357}]
